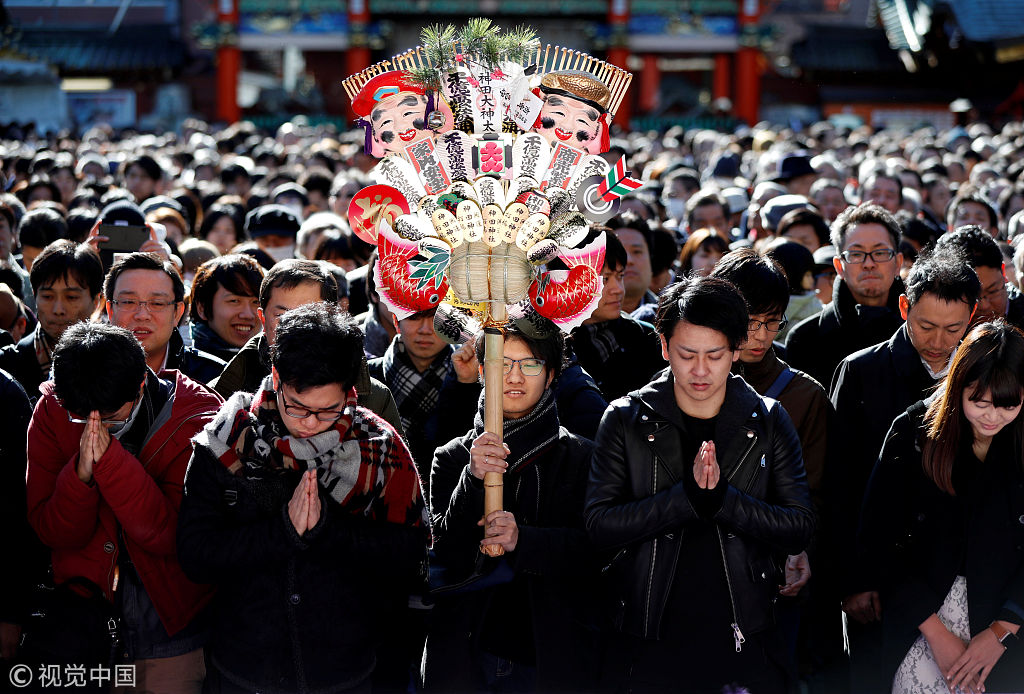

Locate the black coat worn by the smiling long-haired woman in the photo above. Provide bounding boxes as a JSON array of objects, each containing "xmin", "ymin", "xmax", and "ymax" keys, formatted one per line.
[{"xmin": 857, "ymin": 402, "xmax": 1024, "ymax": 692}]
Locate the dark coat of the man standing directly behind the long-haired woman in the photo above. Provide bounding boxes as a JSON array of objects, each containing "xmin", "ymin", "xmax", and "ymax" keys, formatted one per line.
[{"xmin": 825, "ymin": 323, "xmax": 936, "ymax": 597}]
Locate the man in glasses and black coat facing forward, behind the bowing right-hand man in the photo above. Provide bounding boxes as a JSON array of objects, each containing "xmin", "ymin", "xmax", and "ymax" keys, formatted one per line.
[{"xmin": 785, "ymin": 203, "xmax": 903, "ymax": 385}]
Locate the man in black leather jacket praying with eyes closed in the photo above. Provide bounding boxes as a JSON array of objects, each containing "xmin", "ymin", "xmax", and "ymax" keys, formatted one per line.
[{"xmin": 585, "ymin": 277, "xmax": 814, "ymax": 694}]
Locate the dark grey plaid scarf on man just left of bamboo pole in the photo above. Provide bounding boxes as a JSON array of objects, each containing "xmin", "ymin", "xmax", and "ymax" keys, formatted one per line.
[{"xmin": 384, "ymin": 337, "xmax": 454, "ymax": 434}]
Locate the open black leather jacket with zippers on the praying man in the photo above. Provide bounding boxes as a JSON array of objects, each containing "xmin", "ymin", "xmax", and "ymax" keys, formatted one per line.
[{"xmin": 586, "ymin": 368, "xmax": 814, "ymax": 639}]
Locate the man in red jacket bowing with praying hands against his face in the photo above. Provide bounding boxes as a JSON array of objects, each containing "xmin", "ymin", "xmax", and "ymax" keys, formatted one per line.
[{"xmin": 27, "ymin": 322, "xmax": 220, "ymax": 694}]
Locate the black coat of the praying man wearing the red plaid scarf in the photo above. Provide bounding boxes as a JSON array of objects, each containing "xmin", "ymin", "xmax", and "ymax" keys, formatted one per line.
[{"xmin": 177, "ymin": 445, "xmax": 426, "ymax": 694}]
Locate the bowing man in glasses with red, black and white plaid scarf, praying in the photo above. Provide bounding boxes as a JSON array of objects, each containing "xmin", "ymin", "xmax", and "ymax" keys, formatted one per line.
[{"xmin": 178, "ymin": 302, "xmax": 429, "ymax": 694}]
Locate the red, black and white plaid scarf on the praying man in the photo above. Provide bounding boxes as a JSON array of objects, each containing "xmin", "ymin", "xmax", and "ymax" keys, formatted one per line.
[{"xmin": 195, "ymin": 376, "xmax": 426, "ymax": 526}]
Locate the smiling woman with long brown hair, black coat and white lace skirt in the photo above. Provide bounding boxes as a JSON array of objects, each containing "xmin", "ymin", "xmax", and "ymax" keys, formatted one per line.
[{"xmin": 858, "ymin": 320, "xmax": 1024, "ymax": 694}]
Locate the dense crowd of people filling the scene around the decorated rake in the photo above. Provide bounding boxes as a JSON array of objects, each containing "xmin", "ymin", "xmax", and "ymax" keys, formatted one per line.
[{"xmin": 0, "ymin": 116, "xmax": 1024, "ymax": 694}]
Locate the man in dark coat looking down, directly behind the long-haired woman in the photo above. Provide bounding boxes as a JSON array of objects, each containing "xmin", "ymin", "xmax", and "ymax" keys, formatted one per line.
[{"xmin": 824, "ymin": 247, "xmax": 978, "ymax": 692}]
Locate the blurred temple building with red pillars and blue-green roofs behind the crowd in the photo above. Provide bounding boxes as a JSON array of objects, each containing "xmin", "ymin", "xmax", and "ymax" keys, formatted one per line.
[{"xmin": 0, "ymin": 0, "xmax": 1024, "ymax": 130}]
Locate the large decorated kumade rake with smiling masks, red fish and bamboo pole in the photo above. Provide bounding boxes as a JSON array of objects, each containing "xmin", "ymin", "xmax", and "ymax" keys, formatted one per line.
[{"xmin": 343, "ymin": 19, "xmax": 641, "ymax": 556}]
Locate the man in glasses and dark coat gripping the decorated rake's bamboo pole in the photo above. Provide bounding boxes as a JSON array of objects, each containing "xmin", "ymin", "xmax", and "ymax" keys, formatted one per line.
[{"xmin": 423, "ymin": 327, "xmax": 599, "ymax": 692}]
